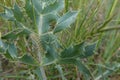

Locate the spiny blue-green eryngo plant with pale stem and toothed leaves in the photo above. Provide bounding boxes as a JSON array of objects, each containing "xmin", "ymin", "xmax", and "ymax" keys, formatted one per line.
[{"xmin": 0, "ymin": 0, "xmax": 95, "ymax": 80}]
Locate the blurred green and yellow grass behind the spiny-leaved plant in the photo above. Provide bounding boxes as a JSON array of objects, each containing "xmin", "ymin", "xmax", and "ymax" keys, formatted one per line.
[{"xmin": 0, "ymin": 0, "xmax": 120, "ymax": 80}]
